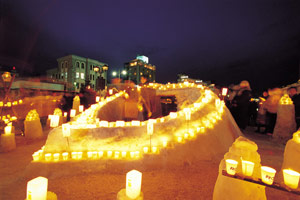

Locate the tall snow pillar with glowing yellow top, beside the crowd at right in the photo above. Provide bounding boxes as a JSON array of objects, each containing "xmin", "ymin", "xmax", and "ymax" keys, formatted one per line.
[{"xmin": 273, "ymin": 94, "xmax": 296, "ymax": 143}]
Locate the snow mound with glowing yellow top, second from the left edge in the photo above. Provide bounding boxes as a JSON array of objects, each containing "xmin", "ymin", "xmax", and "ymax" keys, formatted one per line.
[{"xmin": 24, "ymin": 109, "xmax": 43, "ymax": 139}]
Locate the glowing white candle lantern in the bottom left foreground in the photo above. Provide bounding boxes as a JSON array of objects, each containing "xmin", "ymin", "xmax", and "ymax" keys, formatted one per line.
[{"xmin": 26, "ymin": 176, "xmax": 48, "ymax": 200}]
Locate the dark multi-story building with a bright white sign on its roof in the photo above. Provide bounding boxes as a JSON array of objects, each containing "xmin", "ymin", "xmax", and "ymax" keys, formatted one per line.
[{"xmin": 124, "ymin": 55, "xmax": 156, "ymax": 84}]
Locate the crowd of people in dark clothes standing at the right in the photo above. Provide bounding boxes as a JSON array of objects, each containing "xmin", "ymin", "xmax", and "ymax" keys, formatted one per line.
[{"xmin": 219, "ymin": 80, "xmax": 300, "ymax": 135}]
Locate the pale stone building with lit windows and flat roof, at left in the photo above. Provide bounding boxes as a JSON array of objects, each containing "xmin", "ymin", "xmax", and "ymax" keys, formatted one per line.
[{"xmin": 47, "ymin": 55, "xmax": 108, "ymax": 92}]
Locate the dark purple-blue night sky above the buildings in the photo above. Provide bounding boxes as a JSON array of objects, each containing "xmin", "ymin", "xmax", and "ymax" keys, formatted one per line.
[{"xmin": 0, "ymin": 0, "xmax": 300, "ymax": 91}]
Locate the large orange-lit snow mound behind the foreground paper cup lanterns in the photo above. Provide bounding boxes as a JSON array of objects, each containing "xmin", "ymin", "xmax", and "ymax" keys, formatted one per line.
[{"xmin": 213, "ymin": 136, "xmax": 266, "ymax": 200}]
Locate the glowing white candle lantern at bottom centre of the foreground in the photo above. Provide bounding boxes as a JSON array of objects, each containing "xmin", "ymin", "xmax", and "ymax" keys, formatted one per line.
[{"xmin": 126, "ymin": 170, "xmax": 142, "ymax": 199}]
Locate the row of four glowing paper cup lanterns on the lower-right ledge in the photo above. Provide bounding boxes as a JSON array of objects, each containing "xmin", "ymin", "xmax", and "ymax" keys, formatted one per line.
[{"xmin": 225, "ymin": 159, "xmax": 300, "ymax": 189}]
